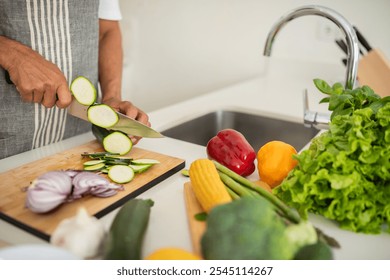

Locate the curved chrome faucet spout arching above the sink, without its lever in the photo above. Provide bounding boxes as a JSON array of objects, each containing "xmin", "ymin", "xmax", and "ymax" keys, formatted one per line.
[{"xmin": 264, "ymin": 5, "xmax": 359, "ymax": 89}]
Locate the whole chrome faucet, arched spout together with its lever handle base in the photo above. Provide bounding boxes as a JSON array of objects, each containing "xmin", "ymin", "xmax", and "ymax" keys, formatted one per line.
[{"xmin": 263, "ymin": 5, "xmax": 359, "ymax": 128}]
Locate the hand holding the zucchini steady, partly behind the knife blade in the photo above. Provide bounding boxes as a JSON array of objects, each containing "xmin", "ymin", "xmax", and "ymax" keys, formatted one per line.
[{"xmin": 103, "ymin": 98, "xmax": 151, "ymax": 144}]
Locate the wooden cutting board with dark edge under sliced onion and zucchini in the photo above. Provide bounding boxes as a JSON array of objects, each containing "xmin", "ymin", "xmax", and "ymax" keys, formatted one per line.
[{"xmin": 0, "ymin": 141, "xmax": 185, "ymax": 240}]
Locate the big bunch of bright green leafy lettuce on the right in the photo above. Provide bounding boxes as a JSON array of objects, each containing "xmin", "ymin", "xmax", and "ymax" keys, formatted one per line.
[{"xmin": 274, "ymin": 79, "xmax": 390, "ymax": 234}]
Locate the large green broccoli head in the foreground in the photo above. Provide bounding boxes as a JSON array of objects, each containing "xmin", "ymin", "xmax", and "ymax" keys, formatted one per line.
[{"xmin": 201, "ymin": 196, "xmax": 315, "ymax": 260}]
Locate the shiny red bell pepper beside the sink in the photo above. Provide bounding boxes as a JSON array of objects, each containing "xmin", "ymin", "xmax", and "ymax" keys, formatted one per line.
[{"xmin": 207, "ymin": 129, "xmax": 256, "ymax": 176}]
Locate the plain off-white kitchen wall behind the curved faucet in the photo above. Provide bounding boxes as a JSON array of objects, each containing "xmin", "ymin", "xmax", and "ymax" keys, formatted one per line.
[{"xmin": 120, "ymin": 0, "xmax": 390, "ymax": 112}]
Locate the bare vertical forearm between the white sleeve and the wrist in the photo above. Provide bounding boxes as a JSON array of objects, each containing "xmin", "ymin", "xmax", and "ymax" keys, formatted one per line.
[{"xmin": 99, "ymin": 20, "xmax": 123, "ymax": 101}]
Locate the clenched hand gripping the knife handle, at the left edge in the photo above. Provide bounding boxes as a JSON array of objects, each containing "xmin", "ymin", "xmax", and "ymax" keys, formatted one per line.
[{"xmin": 0, "ymin": 36, "xmax": 72, "ymax": 108}]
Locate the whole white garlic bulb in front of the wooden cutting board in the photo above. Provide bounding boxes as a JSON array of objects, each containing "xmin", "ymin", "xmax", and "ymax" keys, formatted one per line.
[{"xmin": 50, "ymin": 208, "xmax": 106, "ymax": 259}]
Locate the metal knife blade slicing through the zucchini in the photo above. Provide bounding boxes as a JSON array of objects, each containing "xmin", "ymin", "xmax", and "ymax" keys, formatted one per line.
[{"xmin": 68, "ymin": 99, "xmax": 164, "ymax": 138}]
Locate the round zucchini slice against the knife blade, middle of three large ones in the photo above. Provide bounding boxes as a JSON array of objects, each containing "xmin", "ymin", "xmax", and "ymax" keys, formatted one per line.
[{"xmin": 87, "ymin": 104, "xmax": 119, "ymax": 128}]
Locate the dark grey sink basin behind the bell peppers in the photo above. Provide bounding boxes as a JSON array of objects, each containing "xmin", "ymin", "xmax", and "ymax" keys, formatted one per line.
[{"xmin": 162, "ymin": 110, "xmax": 319, "ymax": 151}]
